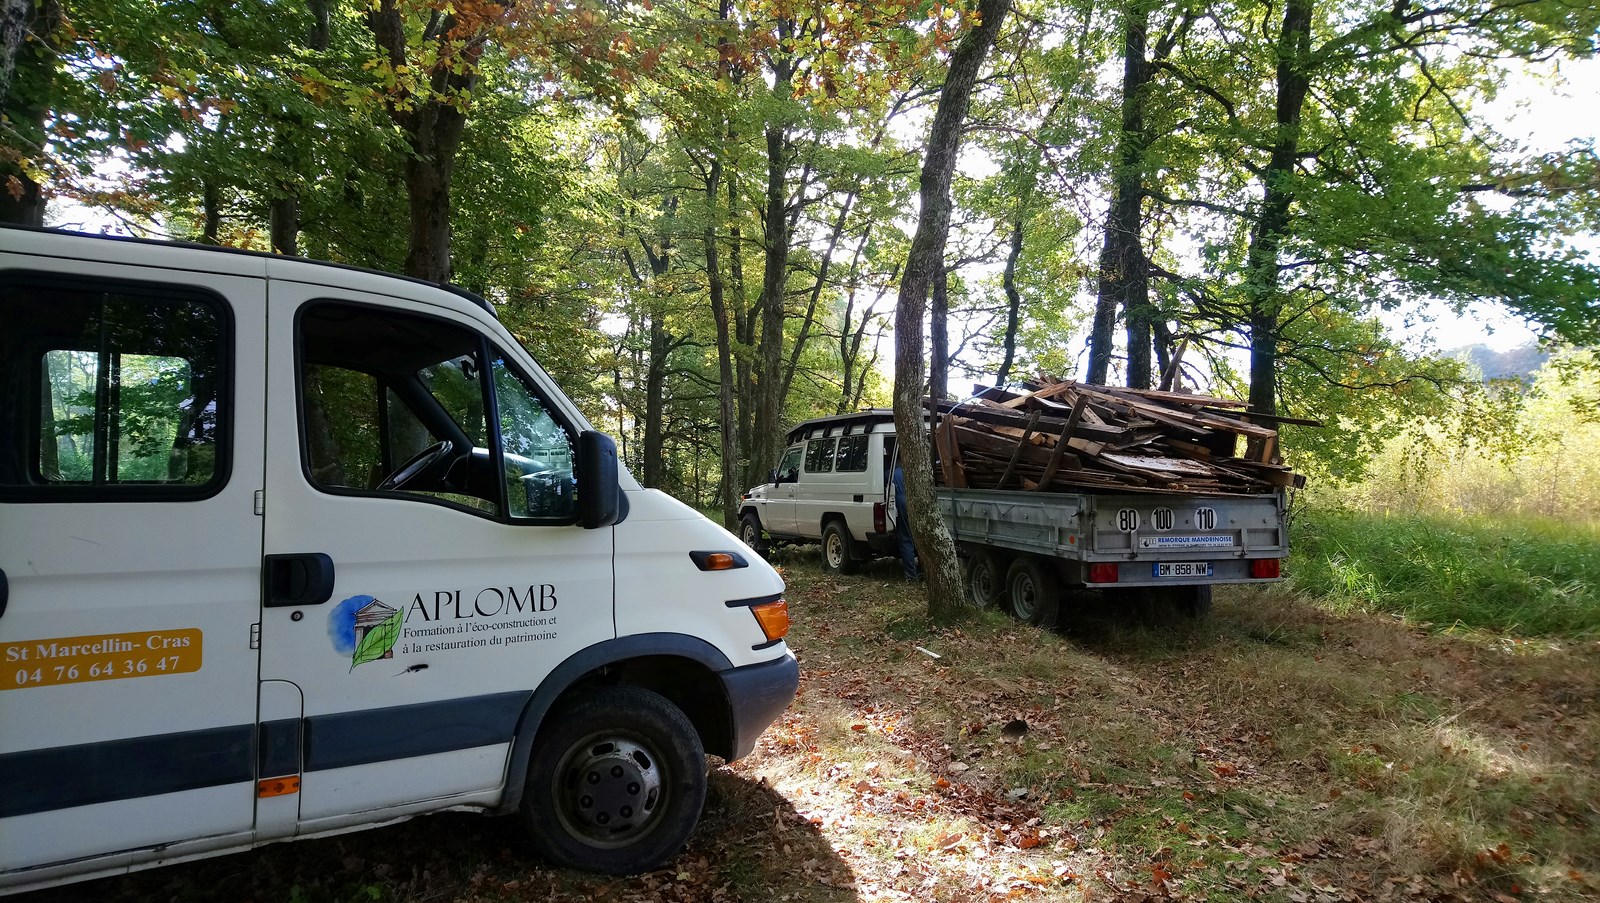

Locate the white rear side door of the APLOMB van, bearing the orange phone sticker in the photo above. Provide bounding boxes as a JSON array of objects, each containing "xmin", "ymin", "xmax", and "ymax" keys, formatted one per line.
[{"xmin": 0, "ymin": 264, "xmax": 266, "ymax": 887}]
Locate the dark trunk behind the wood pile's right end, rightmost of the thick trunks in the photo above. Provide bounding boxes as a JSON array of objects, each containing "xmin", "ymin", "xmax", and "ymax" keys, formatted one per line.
[{"xmin": 1243, "ymin": 0, "xmax": 1314, "ymax": 416}]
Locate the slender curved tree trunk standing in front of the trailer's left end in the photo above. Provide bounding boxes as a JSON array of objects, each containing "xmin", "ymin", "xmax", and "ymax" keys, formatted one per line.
[{"xmin": 894, "ymin": 0, "xmax": 1011, "ymax": 621}]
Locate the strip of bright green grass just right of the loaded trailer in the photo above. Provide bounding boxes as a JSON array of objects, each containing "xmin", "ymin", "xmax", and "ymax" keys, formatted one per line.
[{"xmin": 1290, "ymin": 509, "xmax": 1600, "ymax": 637}]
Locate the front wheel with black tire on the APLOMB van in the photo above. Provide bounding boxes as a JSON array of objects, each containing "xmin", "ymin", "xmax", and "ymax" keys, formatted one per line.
[{"xmin": 520, "ymin": 687, "xmax": 706, "ymax": 874}]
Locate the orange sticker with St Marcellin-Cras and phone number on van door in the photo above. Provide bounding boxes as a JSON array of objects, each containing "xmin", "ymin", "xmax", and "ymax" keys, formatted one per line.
[{"xmin": 0, "ymin": 628, "xmax": 200, "ymax": 690}]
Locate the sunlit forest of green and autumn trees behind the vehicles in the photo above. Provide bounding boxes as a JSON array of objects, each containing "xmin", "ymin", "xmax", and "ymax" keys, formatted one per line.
[{"xmin": 0, "ymin": 0, "xmax": 1600, "ymax": 524}]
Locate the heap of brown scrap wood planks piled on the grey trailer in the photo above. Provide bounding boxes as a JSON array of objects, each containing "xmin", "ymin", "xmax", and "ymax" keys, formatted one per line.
[{"xmin": 934, "ymin": 381, "xmax": 1315, "ymax": 495}]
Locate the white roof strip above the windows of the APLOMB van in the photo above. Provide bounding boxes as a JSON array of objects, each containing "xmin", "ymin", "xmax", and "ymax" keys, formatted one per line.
[{"xmin": 0, "ymin": 223, "xmax": 494, "ymax": 315}]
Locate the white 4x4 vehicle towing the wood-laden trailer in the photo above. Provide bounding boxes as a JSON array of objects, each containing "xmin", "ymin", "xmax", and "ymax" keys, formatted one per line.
[{"xmin": 739, "ymin": 408, "xmax": 898, "ymax": 573}]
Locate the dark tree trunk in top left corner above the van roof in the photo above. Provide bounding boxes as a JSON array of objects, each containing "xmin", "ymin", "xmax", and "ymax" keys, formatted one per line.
[{"xmin": 0, "ymin": 0, "xmax": 61, "ymax": 226}]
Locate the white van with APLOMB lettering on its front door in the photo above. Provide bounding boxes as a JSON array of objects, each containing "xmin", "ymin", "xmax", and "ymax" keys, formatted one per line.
[{"xmin": 0, "ymin": 227, "xmax": 798, "ymax": 892}]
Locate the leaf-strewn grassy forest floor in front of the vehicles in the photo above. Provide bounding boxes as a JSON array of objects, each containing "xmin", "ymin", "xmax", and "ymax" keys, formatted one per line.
[{"xmin": 15, "ymin": 518, "xmax": 1600, "ymax": 903}]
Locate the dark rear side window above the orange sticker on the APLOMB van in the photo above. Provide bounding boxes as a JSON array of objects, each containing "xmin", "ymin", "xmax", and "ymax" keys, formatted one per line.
[{"xmin": 0, "ymin": 274, "xmax": 229, "ymax": 500}]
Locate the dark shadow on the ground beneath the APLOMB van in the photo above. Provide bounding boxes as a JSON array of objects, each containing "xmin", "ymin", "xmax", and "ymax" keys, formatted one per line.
[{"xmin": 16, "ymin": 767, "xmax": 854, "ymax": 903}]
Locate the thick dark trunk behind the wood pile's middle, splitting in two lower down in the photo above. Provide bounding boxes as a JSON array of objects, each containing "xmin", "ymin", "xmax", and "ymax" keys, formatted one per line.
[{"xmin": 1090, "ymin": 0, "xmax": 1152, "ymax": 389}]
